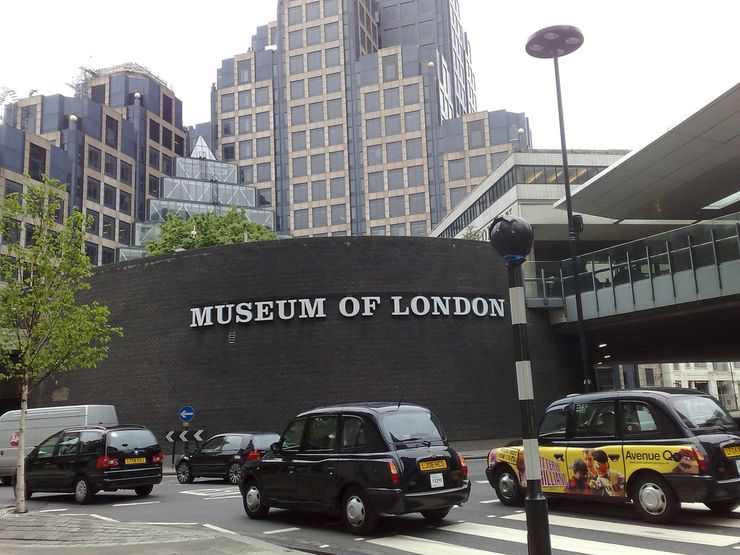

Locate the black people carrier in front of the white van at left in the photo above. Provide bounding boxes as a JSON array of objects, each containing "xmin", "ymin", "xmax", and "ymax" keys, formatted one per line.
[{"xmin": 16, "ymin": 426, "xmax": 164, "ymax": 504}]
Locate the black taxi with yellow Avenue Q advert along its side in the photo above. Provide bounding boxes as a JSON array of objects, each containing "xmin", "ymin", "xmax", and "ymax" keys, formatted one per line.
[{"xmin": 486, "ymin": 388, "xmax": 740, "ymax": 523}]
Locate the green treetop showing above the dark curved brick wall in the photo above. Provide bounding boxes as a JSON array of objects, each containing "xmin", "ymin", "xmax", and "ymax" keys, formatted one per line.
[{"xmin": 145, "ymin": 206, "xmax": 278, "ymax": 256}]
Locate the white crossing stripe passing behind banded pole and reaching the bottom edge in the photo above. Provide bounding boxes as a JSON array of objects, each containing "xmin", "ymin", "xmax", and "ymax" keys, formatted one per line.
[{"xmin": 437, "ymin": 522, "xmax": 673, "ymax": 555}]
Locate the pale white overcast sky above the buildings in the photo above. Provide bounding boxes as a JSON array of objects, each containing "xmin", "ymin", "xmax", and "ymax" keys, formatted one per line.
[{"xmin": 0, "ymin": 0, "xmax": 740, "ymax": 149}]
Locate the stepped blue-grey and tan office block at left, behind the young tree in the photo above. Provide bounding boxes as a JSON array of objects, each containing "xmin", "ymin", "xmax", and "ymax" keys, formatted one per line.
[{"xmin": 0, "ymin": 64, "xmax": 185, "ymax": 264}]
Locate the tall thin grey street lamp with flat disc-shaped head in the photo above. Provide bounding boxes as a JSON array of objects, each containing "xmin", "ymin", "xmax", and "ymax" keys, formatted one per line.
[{"xmin": 526, "ymin": 25, "xmax": 593, "ymax": 392}]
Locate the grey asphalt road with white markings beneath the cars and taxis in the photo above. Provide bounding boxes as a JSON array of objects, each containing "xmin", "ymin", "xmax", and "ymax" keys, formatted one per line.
[{"xmin": 0, "ymin": 460, "xmax": 740, "ymax": 555}]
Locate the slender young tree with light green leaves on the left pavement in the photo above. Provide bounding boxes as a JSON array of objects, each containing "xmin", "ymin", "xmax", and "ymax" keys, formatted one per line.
[{"xmin": 0, "ymin": 176, "xmax": 122, "ymax": 513}]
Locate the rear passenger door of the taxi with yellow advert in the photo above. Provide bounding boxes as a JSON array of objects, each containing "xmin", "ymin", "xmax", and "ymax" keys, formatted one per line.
[{"xmin": 565, "ymin": 400, "xmax": 626, "ymax": 497}]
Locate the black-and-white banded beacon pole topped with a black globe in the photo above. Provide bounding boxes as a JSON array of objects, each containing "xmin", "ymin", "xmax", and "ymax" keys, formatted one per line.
[{"xmin": 488, "ymin": 215, "xmax": 551, "ymax": 555}]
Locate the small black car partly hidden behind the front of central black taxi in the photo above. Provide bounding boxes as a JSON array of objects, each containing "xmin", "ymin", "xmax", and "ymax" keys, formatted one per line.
[{"xmin": 175, "ymin": 432, "xmax": 280, "ymax": 485}]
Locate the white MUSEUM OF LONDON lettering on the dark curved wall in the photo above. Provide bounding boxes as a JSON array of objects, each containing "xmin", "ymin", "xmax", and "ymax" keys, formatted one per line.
[{"xmin": 190, "ymin": 295, "xmax": 505, "ymax": 328}]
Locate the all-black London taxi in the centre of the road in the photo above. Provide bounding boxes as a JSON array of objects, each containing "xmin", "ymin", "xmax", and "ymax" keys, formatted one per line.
[{"xmin": 239, "ymin": 403, "xmax": 470, "ymax": 534}]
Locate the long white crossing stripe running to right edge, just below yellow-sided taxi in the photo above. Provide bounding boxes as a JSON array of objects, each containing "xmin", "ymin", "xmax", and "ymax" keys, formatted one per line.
[{"xmin": 501, "ymin": 515, "xmax": 740, "ymax": 547}]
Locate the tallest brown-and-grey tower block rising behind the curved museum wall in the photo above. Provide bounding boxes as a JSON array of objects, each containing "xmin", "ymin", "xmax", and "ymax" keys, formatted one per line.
[{"xmin": 211, "ymin": 0, "xmax": 531, "ymax": 237}]
